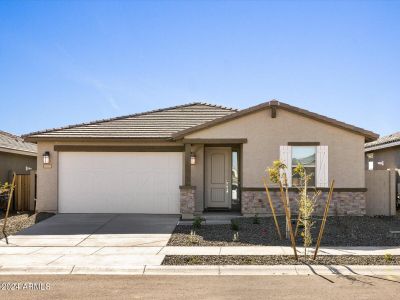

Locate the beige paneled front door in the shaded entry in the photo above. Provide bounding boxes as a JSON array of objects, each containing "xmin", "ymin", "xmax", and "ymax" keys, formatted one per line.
[{"xmin": 205, "ymin": 147, "xmax": 232, "ymax": 209}]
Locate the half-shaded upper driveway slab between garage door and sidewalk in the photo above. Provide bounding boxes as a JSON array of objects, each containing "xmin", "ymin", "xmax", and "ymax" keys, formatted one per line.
[{"xmin": 0, "ymin": 214, "xmax": 179, "ymax": 247}]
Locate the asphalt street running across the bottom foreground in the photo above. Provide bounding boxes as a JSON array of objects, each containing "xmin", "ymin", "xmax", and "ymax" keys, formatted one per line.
[{"xmin": 0, "ymin": 275, "xmax": 400, "ymax": 300}]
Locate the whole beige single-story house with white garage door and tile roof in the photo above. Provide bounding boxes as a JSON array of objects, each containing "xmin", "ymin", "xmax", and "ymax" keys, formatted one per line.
[{"xmin": 25, "ymin": 100, "xmax": 378, "ymax": 218}]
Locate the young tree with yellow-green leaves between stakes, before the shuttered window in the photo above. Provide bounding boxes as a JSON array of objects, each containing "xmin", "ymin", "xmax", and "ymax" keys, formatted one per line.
[{"xmin": 293, "ymin": 164, "xmax": 321, "ymax": 258}]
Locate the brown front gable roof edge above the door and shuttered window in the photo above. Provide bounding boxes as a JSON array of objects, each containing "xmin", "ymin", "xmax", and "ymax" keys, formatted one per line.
[{"xmin": 173, "ymin": 100, "xmax": 379, "ymax": 141}]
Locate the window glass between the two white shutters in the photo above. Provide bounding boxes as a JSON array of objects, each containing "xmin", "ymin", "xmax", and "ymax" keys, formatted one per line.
[{"xmin": 292, "ymin": 146, "xmax": 317, "ymax": 186}]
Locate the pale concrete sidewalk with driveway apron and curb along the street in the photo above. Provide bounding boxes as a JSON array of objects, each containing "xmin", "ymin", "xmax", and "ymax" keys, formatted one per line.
[{"xmin": 0, "ymin": 246, "xmax": 400, "ymax": 274}]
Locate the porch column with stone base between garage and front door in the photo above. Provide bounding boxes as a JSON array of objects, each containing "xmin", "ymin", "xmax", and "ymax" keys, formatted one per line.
[{"xmin": 179, "ymin": 144, "xmax": 196, "ymax": 219}]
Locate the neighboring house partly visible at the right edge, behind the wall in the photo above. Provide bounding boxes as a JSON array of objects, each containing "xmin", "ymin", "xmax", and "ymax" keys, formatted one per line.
[{"xmin": 365, "ymin": 132, "xmax": 400, "ymax": 206}]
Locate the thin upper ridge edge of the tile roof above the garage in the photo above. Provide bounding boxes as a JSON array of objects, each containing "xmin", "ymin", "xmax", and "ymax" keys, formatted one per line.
[{"xmin": 21, "ymin": 102, "xmax": 238, "ymax": 138}]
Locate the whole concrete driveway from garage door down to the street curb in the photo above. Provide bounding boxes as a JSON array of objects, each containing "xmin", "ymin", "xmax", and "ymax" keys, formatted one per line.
[{"xmin": 0, "ymin": 214, "xmax": 179, "ymax": 274}]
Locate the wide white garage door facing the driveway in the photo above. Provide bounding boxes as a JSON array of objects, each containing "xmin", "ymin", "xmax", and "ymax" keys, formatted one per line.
[{"xmin": 58, "ymin": 152, "xmax": 182, "ymax": 214}]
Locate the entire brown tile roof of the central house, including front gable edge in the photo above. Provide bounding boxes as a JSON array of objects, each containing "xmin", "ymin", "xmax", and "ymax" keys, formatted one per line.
[{"xmin": 23, "ymin": 100, "xmax": 379, "ymax": 141}]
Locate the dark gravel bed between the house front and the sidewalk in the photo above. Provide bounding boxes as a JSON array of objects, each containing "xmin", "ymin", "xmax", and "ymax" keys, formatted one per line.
[{"xmin": 168, "ymin": 216, "xmax": 400, "ymax": 246}]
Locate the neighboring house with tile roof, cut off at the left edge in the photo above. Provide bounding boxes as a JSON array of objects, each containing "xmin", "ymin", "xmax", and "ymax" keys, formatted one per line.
[{"xmin": 0, "ymin": 130, "xmax": 37, "ymax": 183}]
